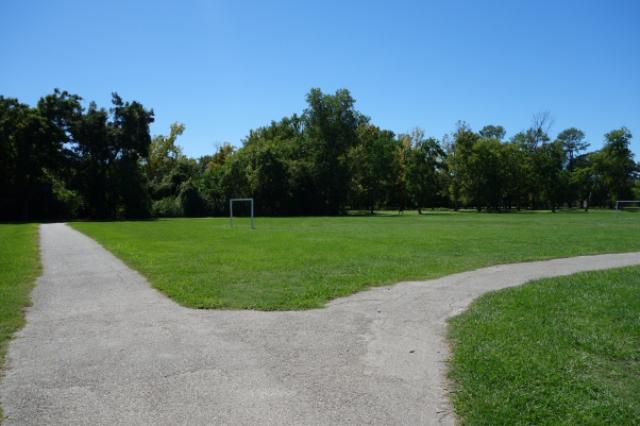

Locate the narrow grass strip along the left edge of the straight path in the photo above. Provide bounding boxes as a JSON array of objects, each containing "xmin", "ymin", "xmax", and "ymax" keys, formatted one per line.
[{"xmin": 0, "ymin": 224, "xmax": 40, "ymax": 423}]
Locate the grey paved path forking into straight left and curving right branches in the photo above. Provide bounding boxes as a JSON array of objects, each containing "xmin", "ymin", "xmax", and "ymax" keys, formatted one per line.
[{"xmin": 0, "ymin": 224, "xmax": 640, "ymax": 425}]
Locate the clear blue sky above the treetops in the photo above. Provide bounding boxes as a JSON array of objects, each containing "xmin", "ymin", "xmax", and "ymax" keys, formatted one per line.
[{"xmin": 0, "ymin": 0, "xmax": 640, "ymax": 159}]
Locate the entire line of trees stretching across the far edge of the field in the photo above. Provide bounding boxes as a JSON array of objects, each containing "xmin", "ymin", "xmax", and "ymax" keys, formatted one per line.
[{"xmin": 0, "ymin": 89, "xmax": 640, "ymax": 220}]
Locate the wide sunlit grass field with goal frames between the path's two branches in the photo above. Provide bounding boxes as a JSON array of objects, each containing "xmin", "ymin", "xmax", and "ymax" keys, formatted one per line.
[{"xmin": 73, "ymin": 211, "xmax": 640, "ymax": 310}]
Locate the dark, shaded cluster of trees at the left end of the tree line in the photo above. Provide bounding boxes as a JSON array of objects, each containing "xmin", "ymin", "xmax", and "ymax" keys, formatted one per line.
[{"xmin": 0, "ymin": 90, "xmax": 153, "ymax": 219}]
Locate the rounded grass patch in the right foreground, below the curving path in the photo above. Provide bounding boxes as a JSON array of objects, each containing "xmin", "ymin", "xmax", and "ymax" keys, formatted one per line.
[{"xmin": 450, "ymin": 267, "xmax": 640, "ymax": 425}]
